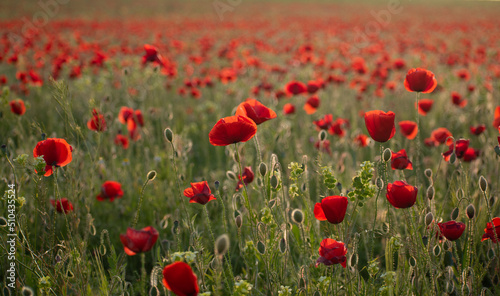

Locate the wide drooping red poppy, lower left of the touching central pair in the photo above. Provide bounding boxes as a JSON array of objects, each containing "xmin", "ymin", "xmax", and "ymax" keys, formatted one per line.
[{"xmin": 208, "ymin": 115, "xmax": 257, "ymax": 146}]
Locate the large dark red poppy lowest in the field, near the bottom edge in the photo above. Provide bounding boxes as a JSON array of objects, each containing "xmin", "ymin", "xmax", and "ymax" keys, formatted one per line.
[{"xmin": 163, "ymin": 261, "xmax": 200, "ymax": 296}]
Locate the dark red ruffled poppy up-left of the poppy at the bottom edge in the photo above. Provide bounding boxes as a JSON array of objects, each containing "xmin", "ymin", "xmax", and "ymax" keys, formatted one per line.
[{"xmin": 120, "ymin": 226, "xmax": 159, "ymax": 256}]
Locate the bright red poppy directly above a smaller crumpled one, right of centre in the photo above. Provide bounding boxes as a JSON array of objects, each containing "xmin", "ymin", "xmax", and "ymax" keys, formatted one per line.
[{"xmin": 314, "ymin": 195, "xmax": 348, "ymax": 224}]
